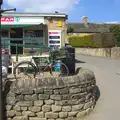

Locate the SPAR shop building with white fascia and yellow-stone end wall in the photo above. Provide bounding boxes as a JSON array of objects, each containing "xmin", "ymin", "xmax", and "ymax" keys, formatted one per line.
[{"xmin": 1, "ymin": 12, "xmax": 67, "ymax": 54}]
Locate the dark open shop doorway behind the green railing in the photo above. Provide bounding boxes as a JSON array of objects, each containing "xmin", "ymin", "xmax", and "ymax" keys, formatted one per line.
[{"xmin": 10, "ymin": 28, "xmax": 23, "ymax": 54}]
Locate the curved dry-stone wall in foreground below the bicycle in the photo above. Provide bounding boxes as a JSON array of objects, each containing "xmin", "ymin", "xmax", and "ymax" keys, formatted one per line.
[{"xmin": 4, "ymin": 69, "xmax": 96, "ymax": 120}]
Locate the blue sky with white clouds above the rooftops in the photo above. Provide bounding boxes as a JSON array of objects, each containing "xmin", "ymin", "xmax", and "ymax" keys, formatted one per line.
[{"xmin": 2, "ymin": 0, "xmax": 120, "ymax": 23}]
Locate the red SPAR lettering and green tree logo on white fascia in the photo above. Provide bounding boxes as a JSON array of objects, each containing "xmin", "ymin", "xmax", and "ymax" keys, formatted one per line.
[{"xmin": 1, "ymin": 17, "xmax": 20, "ymax": 23}]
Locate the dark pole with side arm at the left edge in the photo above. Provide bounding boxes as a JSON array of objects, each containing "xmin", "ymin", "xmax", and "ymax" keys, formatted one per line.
[{"xmin": 0, "ymin": 0, "xmax": 16, "ymax": 120}]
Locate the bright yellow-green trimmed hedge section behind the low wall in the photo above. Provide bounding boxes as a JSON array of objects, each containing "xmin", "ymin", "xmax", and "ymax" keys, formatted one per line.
[{"xmin": 69, "ymin": 35, "xmax": 98, "ymax": 48}]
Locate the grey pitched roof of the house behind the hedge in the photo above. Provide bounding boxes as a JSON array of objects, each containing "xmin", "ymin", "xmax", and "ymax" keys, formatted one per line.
[{"xmin": 67, "ymin": 23, "xmax": 117, "ymax": 33}]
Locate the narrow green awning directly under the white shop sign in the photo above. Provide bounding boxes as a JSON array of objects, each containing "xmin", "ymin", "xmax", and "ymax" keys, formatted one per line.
[{"xmin": 1, "ymin": 24, "xmax": 44, "ymax": 29}]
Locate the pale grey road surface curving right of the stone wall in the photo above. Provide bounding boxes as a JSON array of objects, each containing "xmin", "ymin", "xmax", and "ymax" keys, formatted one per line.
[{"xmin": 76, "ymin": 56, "xmax": 120, "ymax": 120}]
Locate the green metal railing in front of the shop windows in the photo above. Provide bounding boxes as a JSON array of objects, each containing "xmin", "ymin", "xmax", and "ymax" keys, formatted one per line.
[{"xmin": 2, "ymin": 38, "xmax": 48, "ymax": 61}]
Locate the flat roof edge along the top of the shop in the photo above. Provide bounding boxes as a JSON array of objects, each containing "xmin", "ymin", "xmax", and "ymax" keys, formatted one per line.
[{"xmin": 2, "ymin": 12, "xmax": 67, "ymax": 18}]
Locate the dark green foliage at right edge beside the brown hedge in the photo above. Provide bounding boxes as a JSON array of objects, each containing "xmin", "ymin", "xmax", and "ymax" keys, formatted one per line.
[{"xmin": 110, "ymin": 24, "xmax": 120, "ymax": 46}]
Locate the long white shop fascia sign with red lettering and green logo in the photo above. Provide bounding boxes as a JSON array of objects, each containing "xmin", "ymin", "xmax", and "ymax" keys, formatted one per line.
[{"xmin": 1, "ymin": 17, "xmax": 44, "ymax": 25}]
